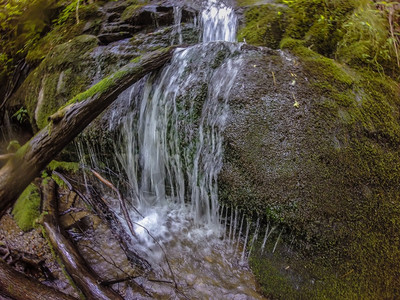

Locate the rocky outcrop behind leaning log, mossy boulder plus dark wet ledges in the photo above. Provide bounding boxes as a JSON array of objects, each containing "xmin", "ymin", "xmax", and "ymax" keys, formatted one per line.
[{"xmin": 8, "ymin": 1, "xmax": 202, "ymax": 132}]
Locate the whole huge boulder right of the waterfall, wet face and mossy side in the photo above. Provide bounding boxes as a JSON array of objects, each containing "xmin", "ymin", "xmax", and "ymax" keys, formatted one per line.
[{"xmin": 219, "ymin": 39, "xmax": 400, "ymax": 299}]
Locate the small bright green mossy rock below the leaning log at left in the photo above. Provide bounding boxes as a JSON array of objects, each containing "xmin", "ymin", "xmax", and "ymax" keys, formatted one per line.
[{"xmin": 12, "ymin": 183, "xmax": 40, "ymax": 231}]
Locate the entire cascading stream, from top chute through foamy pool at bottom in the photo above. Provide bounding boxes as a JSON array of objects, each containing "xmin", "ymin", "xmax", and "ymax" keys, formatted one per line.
[{"xmin": 77, "ymin": 0, "xmax": 261, "ymax": 299}]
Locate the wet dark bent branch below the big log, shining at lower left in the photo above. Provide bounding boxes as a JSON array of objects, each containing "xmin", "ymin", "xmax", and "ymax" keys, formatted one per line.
[{"xmin": 42, "ymin": 179, "xmax": 122, "ymax": 300}]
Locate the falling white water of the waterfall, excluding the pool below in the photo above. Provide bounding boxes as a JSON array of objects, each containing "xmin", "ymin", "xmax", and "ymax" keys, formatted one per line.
[{"xmin": 117, "ymin": 1, "xmax": 241, "ymax": 230}]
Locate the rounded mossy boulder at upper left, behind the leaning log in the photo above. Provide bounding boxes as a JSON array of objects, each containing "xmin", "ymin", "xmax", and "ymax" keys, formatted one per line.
[{"xmin": 11, "ymin": 35, "xmax": 98, "ymax": 129}]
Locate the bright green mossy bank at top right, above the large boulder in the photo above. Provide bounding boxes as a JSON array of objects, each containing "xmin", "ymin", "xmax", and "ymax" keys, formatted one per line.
[{"xmin": 238, "ymin": 0, "xmax": 400, "ymax": 78}]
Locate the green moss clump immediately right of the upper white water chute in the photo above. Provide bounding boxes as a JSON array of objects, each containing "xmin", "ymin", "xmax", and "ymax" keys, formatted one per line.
[{"xmin": 238, "ymin": 4, "xmax": 286, "ymax": 49}]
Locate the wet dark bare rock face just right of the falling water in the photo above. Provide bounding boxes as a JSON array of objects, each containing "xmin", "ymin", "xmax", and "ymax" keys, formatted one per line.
[{"xmin": 220, "ymin": 49, "xmax": 340, "ymax": 239}]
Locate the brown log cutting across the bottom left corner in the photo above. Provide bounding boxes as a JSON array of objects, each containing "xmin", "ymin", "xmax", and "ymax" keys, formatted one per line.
[{"xmin": 0, "ymin": 260, "xmax": 75, "ymax": 300}]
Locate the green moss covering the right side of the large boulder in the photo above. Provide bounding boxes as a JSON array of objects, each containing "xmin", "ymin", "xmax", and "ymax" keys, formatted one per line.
[{"xmin": 244, "ymin": 34, "xmax": 400, "ymax": 299}]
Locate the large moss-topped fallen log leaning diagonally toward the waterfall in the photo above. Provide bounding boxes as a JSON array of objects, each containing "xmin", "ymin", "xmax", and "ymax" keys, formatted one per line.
[{"xmin": 0, "ymin": 48, "xmax": 174, "ymax": 215}]
